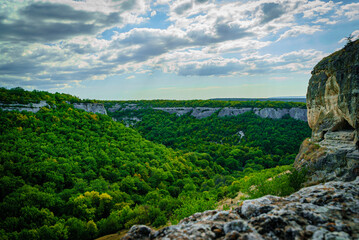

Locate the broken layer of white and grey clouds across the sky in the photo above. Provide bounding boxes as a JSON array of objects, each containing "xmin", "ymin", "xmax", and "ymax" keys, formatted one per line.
[{"xmin": 0, "ymin": 0, "xmax": 359, "ymax": 89}]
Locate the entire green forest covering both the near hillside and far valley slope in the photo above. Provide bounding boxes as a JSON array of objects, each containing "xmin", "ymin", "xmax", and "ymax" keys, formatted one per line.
[{"xmin": 0, "ymin": 88, "xmax": 310, "ymax": 239}]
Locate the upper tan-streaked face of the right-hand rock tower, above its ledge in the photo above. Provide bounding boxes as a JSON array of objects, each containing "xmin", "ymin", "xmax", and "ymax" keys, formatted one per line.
[{"xmin": 307, "ymin": 41, "xmax": 359, "ymax": 141}]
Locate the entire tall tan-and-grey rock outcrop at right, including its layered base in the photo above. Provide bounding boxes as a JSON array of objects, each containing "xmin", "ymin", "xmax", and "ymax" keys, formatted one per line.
[{"xmin": 294, "ymin": 40, "xmax": 359, "ymax": 184}]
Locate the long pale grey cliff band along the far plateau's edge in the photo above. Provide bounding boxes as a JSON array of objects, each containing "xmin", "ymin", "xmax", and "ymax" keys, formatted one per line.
[{"xmin": 108, "ymin": 103, "xmax": 307, "ymax": 121}]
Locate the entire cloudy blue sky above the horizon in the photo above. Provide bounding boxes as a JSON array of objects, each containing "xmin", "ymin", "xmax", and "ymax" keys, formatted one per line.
[{"xmin": 0, "ymin": 0, "xmax": 359, "ymax": 100}]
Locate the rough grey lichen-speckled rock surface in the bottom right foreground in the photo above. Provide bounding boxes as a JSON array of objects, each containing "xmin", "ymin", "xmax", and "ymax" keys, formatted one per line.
[{"xmin": 122, "ymin": 177, "xmax": 359, "ymax": 240}]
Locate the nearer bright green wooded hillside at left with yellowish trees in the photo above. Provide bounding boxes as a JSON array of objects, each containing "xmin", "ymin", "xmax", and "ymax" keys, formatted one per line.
[{"xmin": 0, "ymin": 104, "xmax": 222, "ymax": 239}]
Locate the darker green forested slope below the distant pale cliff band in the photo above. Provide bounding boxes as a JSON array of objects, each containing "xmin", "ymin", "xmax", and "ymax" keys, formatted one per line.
[{"xmin": 109, "ymin": 109, "xmax": 311, "ymax": 173}]
